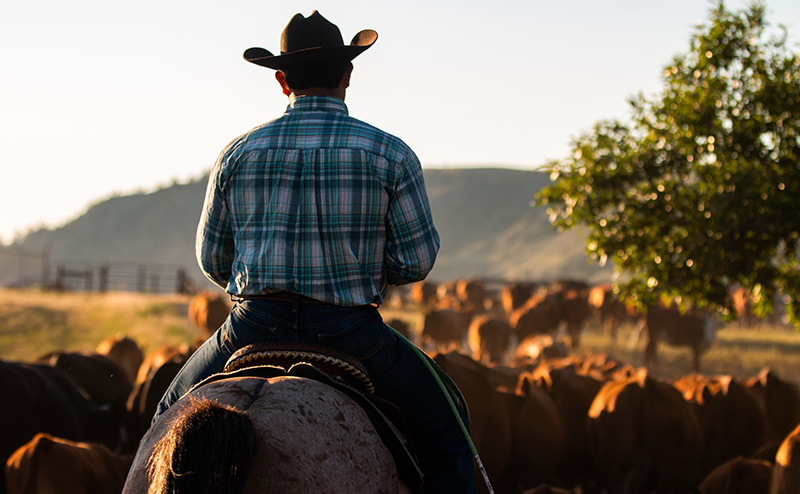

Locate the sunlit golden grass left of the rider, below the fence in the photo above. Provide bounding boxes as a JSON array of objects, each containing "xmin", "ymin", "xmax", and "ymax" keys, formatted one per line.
[{"xmin": 0, "ymin": 289, "xmax": 198, "ymax": 361}]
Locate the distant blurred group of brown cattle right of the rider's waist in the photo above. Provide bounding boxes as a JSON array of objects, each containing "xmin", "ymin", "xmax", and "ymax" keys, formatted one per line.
[{"xmin": 388, "ymin": 279, "xmax": 736, "ymax": 370}]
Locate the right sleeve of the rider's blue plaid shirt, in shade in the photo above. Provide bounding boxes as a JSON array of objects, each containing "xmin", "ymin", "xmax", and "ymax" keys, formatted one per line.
[{"xmin": 384, "ymin": 150, "xmax": 439, "ymax": 285}]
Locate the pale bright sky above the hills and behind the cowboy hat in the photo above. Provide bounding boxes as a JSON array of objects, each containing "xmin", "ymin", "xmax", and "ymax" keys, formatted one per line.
[{"xmin": 0, "ymin": 0, "xmax": 800, "ymax": 244}]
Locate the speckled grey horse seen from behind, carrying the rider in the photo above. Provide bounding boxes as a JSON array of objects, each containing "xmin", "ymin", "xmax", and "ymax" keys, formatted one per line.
[{"xmin": 122, "ymin": 346, "xmax": 421, "ymax": 494}]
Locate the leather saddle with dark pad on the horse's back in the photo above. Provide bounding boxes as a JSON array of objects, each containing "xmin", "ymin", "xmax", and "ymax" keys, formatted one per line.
[{"xmin": 192, "ymin": 342, "xmax": 423, "ymax": 493}]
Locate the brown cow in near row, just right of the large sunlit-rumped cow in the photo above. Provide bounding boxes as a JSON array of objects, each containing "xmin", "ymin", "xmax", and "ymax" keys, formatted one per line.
[{"xmin": 673, "ymin": 374, "xmax": 766, "ymax": 476}]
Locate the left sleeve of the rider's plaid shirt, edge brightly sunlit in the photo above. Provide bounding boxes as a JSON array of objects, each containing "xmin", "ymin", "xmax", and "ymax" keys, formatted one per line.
[{"xmin": 195, "ymin": 153, "xmax": 234, "ymax": 289}]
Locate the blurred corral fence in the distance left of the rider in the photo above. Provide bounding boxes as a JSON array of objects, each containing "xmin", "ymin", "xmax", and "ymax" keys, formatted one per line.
[{"xmin": 0, "ymin": 248, "xmax": 194, "ymax": 293}]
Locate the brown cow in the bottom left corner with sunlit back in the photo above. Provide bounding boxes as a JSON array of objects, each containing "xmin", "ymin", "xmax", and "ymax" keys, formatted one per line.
[{"xmin": 5, "ymin": 433, "xmax": 133, "ymax": 494}]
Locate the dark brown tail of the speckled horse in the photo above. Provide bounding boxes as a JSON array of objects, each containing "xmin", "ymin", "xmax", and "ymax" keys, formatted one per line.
[{"xmin": 148, "ymin": 398, "xmax": 255, "ymax": 494}]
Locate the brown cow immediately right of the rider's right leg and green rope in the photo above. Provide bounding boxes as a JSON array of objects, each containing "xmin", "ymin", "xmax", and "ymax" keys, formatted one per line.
[{"xmin": 433, "ymin": 352, "xmax": 512, "ymax": 494}]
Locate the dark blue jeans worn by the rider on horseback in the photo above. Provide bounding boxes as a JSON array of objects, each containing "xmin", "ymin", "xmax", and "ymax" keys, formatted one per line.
[{"xmin": 156, "ymin": 300, "xmax": 476, "ymax": 494}]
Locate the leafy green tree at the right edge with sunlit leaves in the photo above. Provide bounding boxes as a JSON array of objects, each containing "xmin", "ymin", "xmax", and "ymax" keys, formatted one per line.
[{"xmin": 537, "ymin": 1, "xmax": 800, "ymax": 326}]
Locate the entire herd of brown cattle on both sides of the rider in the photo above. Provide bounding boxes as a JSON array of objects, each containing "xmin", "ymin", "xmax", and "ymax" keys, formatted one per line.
[{"xmin": 0, "ymin": 280, "xmax": 800, "ymax": 494}]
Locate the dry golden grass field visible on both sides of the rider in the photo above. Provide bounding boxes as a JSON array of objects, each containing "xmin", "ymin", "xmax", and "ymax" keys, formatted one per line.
[{"xmin": 0, "ymin": 289, "xmax": 800, "ymax": 385}]
